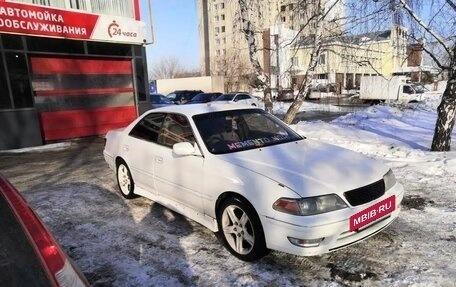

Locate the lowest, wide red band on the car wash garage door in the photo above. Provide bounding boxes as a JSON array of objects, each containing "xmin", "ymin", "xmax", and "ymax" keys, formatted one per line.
[{"xmin": 40, "ymin": 106, "xmax": 136, "ymax": 141}]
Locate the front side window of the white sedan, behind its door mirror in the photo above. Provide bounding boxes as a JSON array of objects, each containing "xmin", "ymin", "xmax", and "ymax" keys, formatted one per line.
[{"xmin": 158, "ymin": 114, "xmax": 195, "ymax": 147}]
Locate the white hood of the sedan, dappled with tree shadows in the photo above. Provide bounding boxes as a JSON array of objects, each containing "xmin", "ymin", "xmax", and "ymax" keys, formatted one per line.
[{"xmin": 218, "ymin": 139, "xmax": 388, "ymax": 197}]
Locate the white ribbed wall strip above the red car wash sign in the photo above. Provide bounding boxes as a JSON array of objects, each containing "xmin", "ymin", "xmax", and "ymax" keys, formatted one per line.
[{"xmin": 11, "ymin": 0, "xmax": 135, "ymax": 18}]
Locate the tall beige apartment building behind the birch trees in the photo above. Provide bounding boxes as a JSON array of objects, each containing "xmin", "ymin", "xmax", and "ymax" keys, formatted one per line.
[{"xmin": 198, "ymin": 0, "xmax": 345, "ymax": 90}]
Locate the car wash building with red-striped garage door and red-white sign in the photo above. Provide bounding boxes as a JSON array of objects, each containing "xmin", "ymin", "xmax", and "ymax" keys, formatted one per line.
[{"xmin": 0, "ymin": 0, "xmax": 148, "ymax": 150}]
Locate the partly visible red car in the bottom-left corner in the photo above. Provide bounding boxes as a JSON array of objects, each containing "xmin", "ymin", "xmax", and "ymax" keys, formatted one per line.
[{"xmin": 0, "ymin": 174, "xmax": 89, "ymax": 287}]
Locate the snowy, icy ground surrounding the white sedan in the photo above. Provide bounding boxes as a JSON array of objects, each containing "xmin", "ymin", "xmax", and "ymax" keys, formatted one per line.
[{"xmin": 0, "ymin": 98, "xmax": 456, "ymax": 286}]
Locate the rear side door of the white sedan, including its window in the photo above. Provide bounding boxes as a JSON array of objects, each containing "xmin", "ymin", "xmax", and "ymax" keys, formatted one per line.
[{"xmin": 121, "ymin": 113, "xmax": 166, "ymax": 196}]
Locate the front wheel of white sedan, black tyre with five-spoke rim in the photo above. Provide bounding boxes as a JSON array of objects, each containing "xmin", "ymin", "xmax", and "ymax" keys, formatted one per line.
[{"xmin": 217, "ymin": 197, "xmax": 268, "ymax": 261}]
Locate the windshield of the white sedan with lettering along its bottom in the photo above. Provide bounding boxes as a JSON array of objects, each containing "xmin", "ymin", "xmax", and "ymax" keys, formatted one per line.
[{"xmin": 193, "ymin": 109, "xmax": 302, "ymax": 154}]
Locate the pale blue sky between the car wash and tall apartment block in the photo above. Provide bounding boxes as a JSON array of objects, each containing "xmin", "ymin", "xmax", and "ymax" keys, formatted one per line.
[{"xmin": 140, "ymin": 0, "xmax": 200, "ymax": 70}]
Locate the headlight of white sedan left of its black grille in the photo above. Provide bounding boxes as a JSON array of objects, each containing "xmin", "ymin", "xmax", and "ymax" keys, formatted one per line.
[{"xmin": 272, "ymin": 194, "xmax": 348, "ymax": 215}]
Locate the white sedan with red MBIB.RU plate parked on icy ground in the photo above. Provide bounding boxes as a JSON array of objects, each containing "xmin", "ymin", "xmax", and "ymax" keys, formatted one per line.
[{"xmin": 104, "ymin": 103, "xmax": 404, "ymax": 261}]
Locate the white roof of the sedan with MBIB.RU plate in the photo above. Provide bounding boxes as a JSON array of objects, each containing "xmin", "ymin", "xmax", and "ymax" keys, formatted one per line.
[{"xmin": 147, "ymin": 102, "xmax": 260, "ymax": 117}]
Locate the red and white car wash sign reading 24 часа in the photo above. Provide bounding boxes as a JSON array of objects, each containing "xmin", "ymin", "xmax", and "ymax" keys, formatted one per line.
[{"xmin": 0, "ymin": 0, "xmax": 146, "ymax": 44}]
